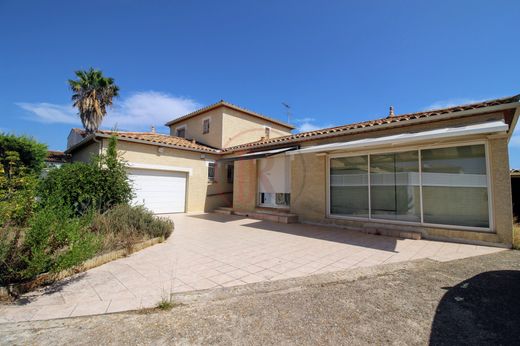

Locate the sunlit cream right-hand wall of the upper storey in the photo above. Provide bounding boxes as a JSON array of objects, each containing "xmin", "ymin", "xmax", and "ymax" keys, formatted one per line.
[{"xmin": 222, "ymin": 108, "xmax": 291, "ymax": 148}]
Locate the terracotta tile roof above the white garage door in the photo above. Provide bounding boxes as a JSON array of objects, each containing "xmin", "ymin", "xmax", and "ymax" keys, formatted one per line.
[{"xmin": 67, "ymin": 129, "xmax": 219, "ymax": 153}]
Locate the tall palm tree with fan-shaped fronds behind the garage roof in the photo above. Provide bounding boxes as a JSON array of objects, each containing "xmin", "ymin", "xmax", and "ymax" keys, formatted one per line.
[{"xmin": 69, "ymin": 67, "xmax": 119, "ymax": 133}]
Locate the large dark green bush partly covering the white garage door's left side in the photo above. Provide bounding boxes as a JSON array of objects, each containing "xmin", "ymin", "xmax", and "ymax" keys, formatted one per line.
[{"xmin": 40, "ymin": 137, "xmax": 133, "ymax": 215}]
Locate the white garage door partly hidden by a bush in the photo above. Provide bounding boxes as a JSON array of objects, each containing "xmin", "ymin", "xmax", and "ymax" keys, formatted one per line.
[{"xmin": 128, "ymin": 168, "xmax": 186, "ymax": 214}]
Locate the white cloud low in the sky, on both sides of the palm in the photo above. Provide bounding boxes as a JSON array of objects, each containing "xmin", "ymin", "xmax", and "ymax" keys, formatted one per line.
[{"xmin": 17, "ymin": 91, "xmax": 201, "ymax": 130}]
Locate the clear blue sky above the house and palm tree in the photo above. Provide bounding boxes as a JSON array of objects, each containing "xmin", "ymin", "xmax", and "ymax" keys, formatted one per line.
[{"xmin": 0, "ymin": 0, "xmax": 520, "ymax": 168}]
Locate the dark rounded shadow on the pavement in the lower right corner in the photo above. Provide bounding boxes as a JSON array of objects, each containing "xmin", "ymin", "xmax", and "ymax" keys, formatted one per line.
[{"xmin": 430, "ymin": 270, "xmax": 520, "ymax": 345}]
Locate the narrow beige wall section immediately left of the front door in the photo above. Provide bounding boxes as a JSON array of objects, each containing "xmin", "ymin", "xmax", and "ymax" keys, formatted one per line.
[{"xmin": 233, "ymin": 160, "xmax": 258, "ymax": 212}]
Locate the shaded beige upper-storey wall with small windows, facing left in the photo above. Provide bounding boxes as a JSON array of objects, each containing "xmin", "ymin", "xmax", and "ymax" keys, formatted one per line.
[{"xmin": 170, "ymin": 107, "xmax": 222, "ymax": 148}]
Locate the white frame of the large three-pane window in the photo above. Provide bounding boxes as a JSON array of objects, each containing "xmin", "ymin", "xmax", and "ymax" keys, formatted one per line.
[{"xmin": 325, "ymin": 140, "xmax": 495, "ymax": 233}]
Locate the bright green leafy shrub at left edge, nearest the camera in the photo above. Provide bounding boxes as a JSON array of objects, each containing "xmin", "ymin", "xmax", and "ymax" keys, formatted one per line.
[{"xmin": 0, "ymin": 202, "xmax": 101, "ymax": 285}]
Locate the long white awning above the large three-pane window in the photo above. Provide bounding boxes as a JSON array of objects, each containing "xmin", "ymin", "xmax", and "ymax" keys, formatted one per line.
[{"xmin": 288, "ymin": 121, "xmax": 509, "ymax": 155}]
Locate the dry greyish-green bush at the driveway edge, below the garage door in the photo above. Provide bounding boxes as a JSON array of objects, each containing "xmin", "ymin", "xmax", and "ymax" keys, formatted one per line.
[{"xmin": 92, "ymin": 204, "xmax": 173, "ymax": 251}]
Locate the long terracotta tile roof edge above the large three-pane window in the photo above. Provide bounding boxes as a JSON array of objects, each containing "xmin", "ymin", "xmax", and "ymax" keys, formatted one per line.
[{"xmin": 223, "ymin": 94, "xmax": 520, "ymax": 152}]
